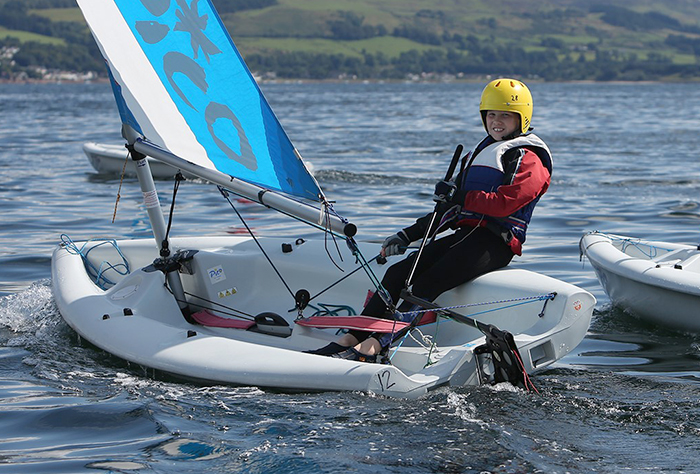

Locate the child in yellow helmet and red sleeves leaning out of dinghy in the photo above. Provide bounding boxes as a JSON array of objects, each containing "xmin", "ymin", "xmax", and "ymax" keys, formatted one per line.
[{"xmin": 311, "ymin": 78, "xmax": 552, "ymax": 362}]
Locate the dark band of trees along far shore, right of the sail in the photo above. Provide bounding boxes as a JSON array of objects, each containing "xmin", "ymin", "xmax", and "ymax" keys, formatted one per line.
[{"xmin": 246, "ymin": 46, "xmax": 700, "ymax": 81}]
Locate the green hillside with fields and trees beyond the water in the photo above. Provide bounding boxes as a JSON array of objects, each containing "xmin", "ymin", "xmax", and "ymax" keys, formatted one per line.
[{"xmin": 0, "ymin": 0, "xmax": 700, "ymax": 80}]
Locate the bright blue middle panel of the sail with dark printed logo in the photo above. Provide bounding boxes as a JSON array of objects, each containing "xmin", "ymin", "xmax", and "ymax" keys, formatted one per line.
[{"xmin": 117, "ymin": 0, "xmax": 266, "ymax": 170}]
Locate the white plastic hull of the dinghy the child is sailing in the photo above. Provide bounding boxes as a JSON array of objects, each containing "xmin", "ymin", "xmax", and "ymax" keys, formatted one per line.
[{"xmin": 52, "ymin": 236, "xmax": 595, "ymax": 398}]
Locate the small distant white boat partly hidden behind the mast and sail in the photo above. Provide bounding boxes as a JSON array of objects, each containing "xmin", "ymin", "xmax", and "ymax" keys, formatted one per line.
[{"xmin": 83, "ymin": 142, "xmax": 194, "ymax": 179}]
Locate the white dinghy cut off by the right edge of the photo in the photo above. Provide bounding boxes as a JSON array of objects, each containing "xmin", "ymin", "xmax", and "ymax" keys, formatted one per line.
[{"xmin": 579, "ymin": 232, "xmax": 700, "ymax": 332}]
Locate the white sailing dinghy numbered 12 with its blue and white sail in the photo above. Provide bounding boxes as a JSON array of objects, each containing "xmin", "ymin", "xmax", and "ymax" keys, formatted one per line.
[{"xmin": 52, "ymin": 0, "xmax": 595, "ymax": 397}]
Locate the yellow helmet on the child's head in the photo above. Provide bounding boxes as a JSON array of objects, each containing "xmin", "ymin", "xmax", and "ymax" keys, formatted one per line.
[{"xmin": 479, "ymin": 78, "xmax": 532, "ymax": 133}]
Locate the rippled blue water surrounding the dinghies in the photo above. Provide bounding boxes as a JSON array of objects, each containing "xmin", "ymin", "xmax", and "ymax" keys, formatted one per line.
[{"xmin": 0, "ymin": 84, "xmax": 700, "ymax": 473}]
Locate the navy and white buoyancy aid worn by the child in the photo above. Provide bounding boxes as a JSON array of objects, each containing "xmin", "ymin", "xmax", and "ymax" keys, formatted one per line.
[{"xmin": 443, "ymin": 134, "xmax": 552, "ymax": 255}]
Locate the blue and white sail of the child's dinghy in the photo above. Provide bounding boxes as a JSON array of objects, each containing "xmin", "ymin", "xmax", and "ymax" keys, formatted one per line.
[{"xmin": 78, "ymin": 0, "xmax": 323, "ymax": 200}]
